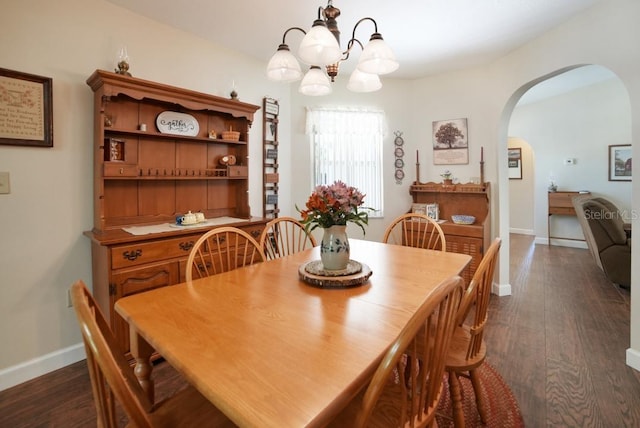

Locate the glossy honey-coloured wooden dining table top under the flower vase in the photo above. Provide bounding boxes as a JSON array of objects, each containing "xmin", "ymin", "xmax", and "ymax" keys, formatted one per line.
[{"xmin": 115, "ymin": 239, "xmax": 471, "ymax": 428}]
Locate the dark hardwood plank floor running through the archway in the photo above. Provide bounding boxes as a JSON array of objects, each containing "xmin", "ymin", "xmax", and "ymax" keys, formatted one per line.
[{"xmin": 0, "ymin": 235, "xmax": 640, "ymax": 428}]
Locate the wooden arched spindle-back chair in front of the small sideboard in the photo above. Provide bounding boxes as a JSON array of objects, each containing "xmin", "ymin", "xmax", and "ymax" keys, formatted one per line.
[{"xmin": 382, "ymin": 213, "xmax": 447, "ymax": 251}]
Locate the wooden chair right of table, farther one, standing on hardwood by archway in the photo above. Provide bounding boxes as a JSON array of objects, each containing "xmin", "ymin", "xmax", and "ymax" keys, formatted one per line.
[{"xmin": 446, "ymin": 238, "xmax": 502, "ymax": 427}]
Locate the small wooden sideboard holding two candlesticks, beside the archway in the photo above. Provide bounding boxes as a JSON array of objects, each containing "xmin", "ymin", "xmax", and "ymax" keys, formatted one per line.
[{"xmin": 409, "ymin": 182, "xmax": 491, "ymax": 284}]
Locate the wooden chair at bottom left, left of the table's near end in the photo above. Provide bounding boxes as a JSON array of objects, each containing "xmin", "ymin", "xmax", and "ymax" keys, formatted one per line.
[{"xmin": 70, "ymin": 280, "xmax": 235, "ymax": 428}]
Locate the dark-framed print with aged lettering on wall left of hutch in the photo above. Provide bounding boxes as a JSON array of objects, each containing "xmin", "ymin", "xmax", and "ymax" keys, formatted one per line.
[{"xmin": 0, "ymin": 68, "xmax": 53, "ymax": 147}]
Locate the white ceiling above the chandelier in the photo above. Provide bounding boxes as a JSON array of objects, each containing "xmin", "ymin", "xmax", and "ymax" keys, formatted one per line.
[{"xmin": 109, "ymin": 0, "xmax": 601, "ymax": 79}]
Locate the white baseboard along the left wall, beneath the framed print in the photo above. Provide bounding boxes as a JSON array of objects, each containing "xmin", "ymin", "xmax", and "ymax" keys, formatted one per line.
[{"xmin": 0, "ymin": 343, "xmax": 86, "ymax": 391}]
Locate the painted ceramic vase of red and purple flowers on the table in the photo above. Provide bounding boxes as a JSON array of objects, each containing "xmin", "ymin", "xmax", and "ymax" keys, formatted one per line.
[{"xmin": 298, "ymin": 181, "xmax": 369, "ymax": 270}]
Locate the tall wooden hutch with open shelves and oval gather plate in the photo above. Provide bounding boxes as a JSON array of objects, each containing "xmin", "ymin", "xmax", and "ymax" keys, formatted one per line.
[{"xmin": 85, "ymin": 70, "xmax": 266, "ymax": 350}]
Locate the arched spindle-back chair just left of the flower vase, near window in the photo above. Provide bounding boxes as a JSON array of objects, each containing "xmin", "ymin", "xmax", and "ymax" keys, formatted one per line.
[{"xmin": 260, "ymin": 217, "xmax": 317, "ymax": 260}]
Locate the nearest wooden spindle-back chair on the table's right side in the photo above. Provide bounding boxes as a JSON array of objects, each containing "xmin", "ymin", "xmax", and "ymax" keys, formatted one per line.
[{"xmin": 329, "ymin": 276, "xmax": 464, "ymax": 428}]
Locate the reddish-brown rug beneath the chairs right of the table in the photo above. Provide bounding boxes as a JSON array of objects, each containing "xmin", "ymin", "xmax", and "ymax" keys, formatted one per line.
[{"xmin": 436, "ymin": 361, "xmax": 524, "ymax": 428}]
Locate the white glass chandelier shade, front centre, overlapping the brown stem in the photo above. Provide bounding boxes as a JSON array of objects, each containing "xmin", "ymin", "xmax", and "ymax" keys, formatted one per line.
[{"xmin": 298, "ymin": 20, "xmax": 342, "ymax": 66}]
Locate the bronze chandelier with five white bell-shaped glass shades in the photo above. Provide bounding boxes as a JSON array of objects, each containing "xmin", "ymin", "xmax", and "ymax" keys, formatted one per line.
[{"xmin": 267, "ymin": 0, "xmax": 398, "ymax": 95}]
